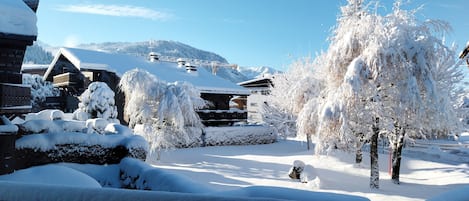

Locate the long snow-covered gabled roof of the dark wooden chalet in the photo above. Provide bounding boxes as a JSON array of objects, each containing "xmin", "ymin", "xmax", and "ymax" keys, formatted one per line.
[{"xmin": 44, "ymin": 48, "xmax": 250, "ymax": 95}]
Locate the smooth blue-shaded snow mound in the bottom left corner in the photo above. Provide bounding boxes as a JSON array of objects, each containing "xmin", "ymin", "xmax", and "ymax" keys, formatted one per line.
[{"xmin": 0, "ymin": 165, "xmax": 101, "ymax": 188}]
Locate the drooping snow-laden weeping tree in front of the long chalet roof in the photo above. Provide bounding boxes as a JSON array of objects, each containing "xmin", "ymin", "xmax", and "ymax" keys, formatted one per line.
[{"xmin": 119, "ymin": 69, "xmax": 206, "ymax": 159}]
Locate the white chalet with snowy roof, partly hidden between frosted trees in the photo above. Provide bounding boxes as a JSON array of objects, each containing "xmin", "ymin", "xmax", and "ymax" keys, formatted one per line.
[{"xmin": 238, "ymin": 76, "xmax": 272, "ymax": 123}]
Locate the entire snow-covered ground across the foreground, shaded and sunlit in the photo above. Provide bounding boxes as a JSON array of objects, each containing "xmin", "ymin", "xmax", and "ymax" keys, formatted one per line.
[{"xmin": 0, "ymin": 133, "xmax": 469, "ymax": 200}]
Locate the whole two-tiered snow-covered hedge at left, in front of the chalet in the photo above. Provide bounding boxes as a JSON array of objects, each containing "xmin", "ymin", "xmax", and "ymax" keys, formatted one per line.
[{"xmin": 16, "ymin": 110, "xmax": 149, "ymax": 169}]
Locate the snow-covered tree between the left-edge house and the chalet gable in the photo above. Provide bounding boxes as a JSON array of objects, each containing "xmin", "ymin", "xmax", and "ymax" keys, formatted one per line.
[{"xmin": 23, "ymin": 74, "xmax": 60, "ymax": 112}]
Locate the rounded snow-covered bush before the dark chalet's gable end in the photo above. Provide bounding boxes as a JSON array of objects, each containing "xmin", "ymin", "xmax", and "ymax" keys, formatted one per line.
[{"xmin": 74, "ymin": 82, "xmax": 119, "ymax": 123}]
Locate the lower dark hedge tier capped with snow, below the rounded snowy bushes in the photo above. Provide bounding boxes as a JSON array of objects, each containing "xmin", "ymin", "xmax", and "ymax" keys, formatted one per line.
[{"xmin": 16, "ymin": 133, "xmax": 148, "ymax": 169}]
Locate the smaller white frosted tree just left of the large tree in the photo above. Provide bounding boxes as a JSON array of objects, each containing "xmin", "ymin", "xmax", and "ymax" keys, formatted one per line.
[{"xmin": 262, "ymin": 57, "xmax": 321, "ymax": 148}]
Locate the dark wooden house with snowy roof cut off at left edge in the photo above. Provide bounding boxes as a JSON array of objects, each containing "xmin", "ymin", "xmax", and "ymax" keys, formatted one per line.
[{"xmin": 0, "ymin": 0, "xmax": 39, "ymax": 114}]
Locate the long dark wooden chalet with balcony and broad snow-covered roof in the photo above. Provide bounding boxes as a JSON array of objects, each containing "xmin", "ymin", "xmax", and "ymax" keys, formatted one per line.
[{"xmin": 44, "ymin": 48, "xmax": 250, "ymax": 125}]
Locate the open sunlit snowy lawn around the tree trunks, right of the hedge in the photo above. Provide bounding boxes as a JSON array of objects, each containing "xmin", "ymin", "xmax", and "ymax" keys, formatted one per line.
[{"xmin": 153, "ymin": 137, "xmax": 469, "ymax": 200}]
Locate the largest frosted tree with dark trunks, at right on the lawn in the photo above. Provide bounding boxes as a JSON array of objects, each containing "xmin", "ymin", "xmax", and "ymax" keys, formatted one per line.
[{"xmin": 266, "ymin": 0, "xmax": 460, "ymax": 188}]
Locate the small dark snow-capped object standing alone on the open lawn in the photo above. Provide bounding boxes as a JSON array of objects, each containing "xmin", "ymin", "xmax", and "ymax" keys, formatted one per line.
[{"xmin": 288, "ymin": 160, "xmax": 320, "ymax": 188}]
